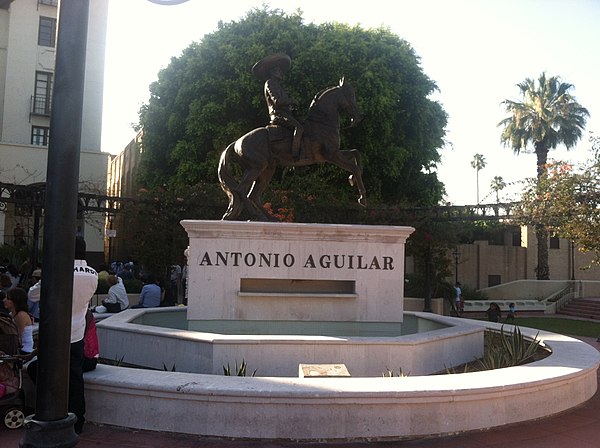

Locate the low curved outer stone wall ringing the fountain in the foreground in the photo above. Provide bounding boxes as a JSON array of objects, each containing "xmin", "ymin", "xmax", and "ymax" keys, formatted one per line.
[{"xmin": 85, "ymin": 313, "xmax": 600, "ymax": 441}]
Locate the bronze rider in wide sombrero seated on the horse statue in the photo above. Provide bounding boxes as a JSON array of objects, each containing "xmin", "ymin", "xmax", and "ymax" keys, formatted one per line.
[{"xmin": 252, "ymin": 53, "xmax": 304, "ymax": 161}]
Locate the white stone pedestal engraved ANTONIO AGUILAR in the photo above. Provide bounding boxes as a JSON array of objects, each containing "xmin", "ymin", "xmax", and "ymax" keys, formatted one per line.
[{"xmin": 181, "ymin": 220, "xmax": 414, "ymax": 322}]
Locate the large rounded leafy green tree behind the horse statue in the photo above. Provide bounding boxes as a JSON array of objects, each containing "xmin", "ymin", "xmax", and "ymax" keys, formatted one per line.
[{"xmin": 139, "ymin": 6, "xmax": 447, "ymax": 220}]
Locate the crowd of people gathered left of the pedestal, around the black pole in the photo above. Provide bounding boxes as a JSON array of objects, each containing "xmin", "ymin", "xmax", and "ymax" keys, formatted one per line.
[{"xmin": 0, "ymin": 236, "xmax": 187, "ymax": 433}]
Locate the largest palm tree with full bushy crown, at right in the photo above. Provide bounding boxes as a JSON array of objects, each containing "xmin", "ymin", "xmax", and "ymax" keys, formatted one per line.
[{"xmin": 498, "ymin": 73, "xmax": 590, "ymax": 280}]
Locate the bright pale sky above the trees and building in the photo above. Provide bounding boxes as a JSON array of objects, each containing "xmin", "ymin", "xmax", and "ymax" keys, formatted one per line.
[{"xmin": 102, "ymin": 0, "xmax": 600, "ymax": 205}]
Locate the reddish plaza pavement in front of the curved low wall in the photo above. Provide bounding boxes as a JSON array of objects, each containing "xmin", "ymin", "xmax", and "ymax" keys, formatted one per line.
[{"xmin": 0, "ymin": 338, "xmax": 600, "ymax": 448}]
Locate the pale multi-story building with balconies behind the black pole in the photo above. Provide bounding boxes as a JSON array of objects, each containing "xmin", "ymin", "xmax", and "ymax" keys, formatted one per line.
[{"xmin": 0, "ymin": 0, "xmax": 110, "ymax": 266}]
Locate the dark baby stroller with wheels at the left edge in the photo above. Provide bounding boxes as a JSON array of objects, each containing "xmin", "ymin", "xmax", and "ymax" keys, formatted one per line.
[{"xmin": 0, "ymin": 315, "xmax": 25, "ymax": 429}]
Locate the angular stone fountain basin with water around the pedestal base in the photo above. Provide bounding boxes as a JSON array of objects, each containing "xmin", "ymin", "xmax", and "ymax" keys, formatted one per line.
[{"xmin": 98, "ymin": 307, "xmax": 483, "ymax": 377}]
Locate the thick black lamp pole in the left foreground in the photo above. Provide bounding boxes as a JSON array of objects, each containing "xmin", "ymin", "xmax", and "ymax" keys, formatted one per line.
[{"xmin": 20, "ymin": 0, "xmax": 89, "ymax": 448}]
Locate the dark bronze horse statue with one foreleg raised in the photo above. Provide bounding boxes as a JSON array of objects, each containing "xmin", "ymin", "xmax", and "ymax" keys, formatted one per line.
[{"xmin": 218, "ymin": 79, "xmax": 366, "ymax": 221}]
